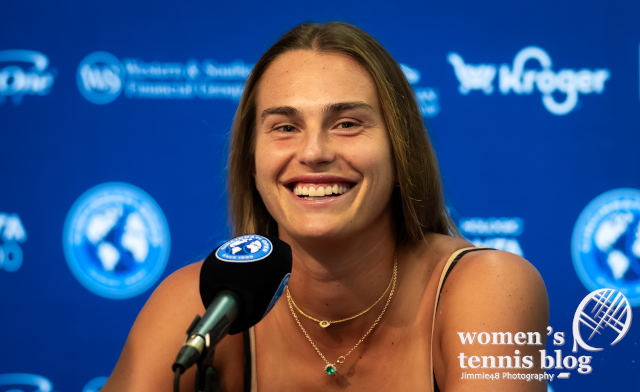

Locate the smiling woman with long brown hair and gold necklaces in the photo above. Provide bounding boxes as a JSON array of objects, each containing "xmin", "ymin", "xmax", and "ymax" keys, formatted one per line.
[{"xmin": 103, "ymin": 23, "xmax": 548, "ymax": 392}]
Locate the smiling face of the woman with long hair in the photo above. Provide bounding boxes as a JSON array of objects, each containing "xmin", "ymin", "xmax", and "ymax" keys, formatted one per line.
[{"xmin": 255, "ymin": 50, "xmax": 395, "ymax": 239}]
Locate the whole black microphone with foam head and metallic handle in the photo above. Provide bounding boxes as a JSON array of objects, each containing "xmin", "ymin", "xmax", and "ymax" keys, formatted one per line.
[{"xmin": 172, "ymin": 234, "xmax": 291, "ymax": 373}]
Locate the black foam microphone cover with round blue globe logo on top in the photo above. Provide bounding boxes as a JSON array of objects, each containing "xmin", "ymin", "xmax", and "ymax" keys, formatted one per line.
[{"xmin": 200, "ymin": 234, "xmax": 292, "ymax": 334}]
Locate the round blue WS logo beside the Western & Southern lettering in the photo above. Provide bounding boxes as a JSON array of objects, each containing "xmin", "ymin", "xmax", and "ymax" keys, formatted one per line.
[{"xmin": 76, "ymin": 52, "xmax": 125, "ymax": 105}]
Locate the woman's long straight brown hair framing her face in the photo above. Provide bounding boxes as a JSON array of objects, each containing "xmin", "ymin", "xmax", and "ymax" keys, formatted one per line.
[{"xmin": 228, "ymin": 22, "xmax": 458, "ymax": 242}]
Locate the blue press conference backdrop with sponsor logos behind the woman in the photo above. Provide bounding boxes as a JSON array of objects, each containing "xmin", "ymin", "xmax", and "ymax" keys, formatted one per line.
[{"xmin": 0, "ymin": 0, "xmax": 640, "ymax": 392}]
